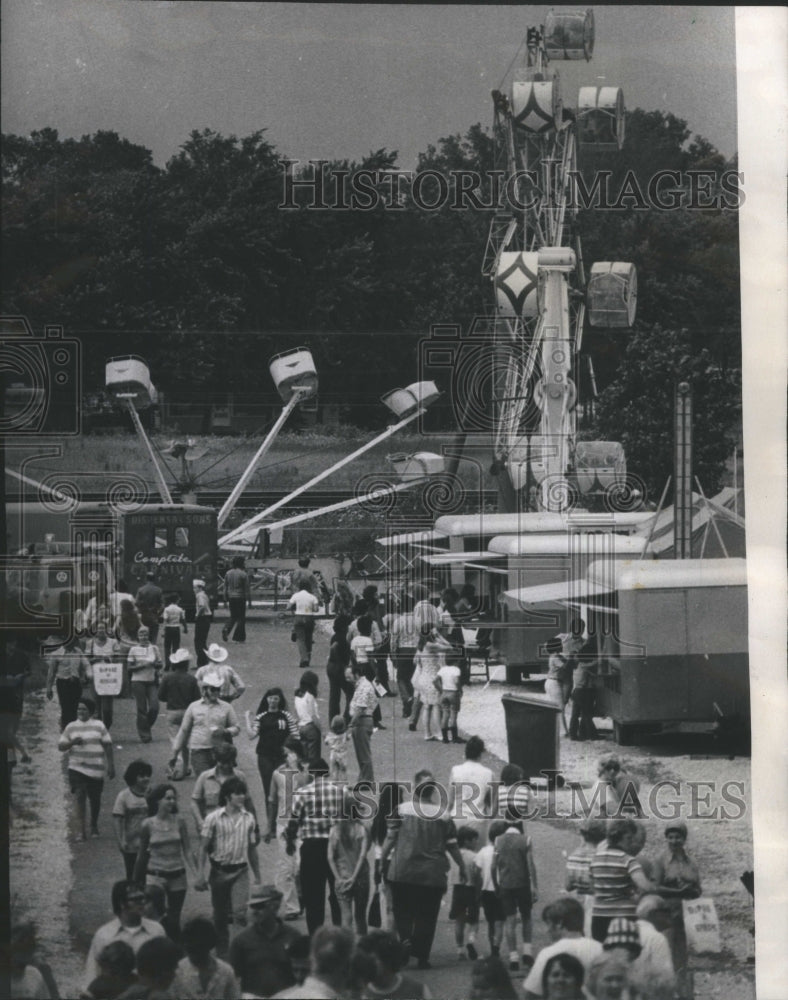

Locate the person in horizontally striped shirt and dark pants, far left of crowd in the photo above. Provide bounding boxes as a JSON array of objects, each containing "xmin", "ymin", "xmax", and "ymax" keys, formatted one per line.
[{"xmin": 58, "ymin": 698, "xmax": 115, "ymax": 842}]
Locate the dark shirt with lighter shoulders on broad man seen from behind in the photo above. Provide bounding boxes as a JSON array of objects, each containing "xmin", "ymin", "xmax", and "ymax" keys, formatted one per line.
[{"xmin": 388, "ymin": 802, "xmax": 457, "ymax": 889}]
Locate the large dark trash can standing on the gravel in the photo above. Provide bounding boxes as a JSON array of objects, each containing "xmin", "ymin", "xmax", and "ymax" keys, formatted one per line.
[{"xmin": 501, "ymin": 694, "xmax": 561, "ymax": 788}]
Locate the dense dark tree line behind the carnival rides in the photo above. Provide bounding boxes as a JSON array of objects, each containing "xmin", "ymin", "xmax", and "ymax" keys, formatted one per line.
[{"xmin": 2, "ymin": 110, "xmax": 740, "ymax": 492}]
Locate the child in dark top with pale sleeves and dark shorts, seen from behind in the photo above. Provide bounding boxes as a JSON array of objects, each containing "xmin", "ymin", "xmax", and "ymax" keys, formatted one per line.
[{"xmin": 492, "ymin": 822, "xmax": 537, "ymax": 972}]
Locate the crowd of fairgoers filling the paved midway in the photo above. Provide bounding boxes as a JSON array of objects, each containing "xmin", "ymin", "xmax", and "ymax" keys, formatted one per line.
[{"xmin": 4, "ymin": 559, "xmax": 701, "ymax": 1000}]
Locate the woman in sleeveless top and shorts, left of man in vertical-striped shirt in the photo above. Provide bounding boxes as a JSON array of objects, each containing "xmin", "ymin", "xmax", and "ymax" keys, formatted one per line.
[{"xmin": 134, "ymin": 785, "xmax": 197, "ymax": 941}]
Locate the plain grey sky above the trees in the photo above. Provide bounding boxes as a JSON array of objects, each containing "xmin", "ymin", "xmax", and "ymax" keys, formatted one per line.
[{"xmin": 2, "ymin": 0, "xmax": 736, "ymax": 168}]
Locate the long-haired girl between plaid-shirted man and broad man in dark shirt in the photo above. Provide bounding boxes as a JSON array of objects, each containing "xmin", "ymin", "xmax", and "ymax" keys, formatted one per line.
[{"xmin": 328, "ymin": 797, "xmax": 372, "ymax": 935}]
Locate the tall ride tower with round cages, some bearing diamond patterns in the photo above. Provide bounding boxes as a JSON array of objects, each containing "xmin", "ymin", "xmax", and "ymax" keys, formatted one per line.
[{"xmin": 482, "ymin": 9, "xmax": 637, "ymax": 511}]
